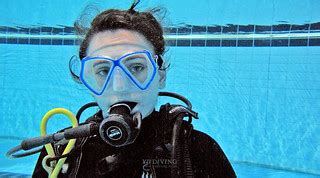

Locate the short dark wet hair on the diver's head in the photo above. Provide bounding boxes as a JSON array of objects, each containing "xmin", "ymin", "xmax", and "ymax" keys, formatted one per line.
[{"xmin": 75, "ymin": 4, "xmax": 167, "ymax": 70}]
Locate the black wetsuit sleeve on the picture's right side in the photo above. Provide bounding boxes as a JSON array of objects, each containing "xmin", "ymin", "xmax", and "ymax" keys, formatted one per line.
[{"xmin": 190, "ymin": 130, "xmax": 236, "ymax": 178}]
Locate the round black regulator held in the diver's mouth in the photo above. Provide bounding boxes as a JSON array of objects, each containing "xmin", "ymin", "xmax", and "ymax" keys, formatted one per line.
[{"xmin": 99, "ymin": 103, "xmax": 142, "ymax": 147}]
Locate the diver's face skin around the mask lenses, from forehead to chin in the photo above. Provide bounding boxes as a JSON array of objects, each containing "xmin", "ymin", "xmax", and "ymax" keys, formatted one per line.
[{"xmin": 87, "ymin": 29, "xmax": 165, "ymax": 118}]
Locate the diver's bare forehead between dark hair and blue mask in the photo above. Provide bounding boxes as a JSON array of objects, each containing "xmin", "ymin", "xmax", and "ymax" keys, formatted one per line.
[{"xmin": 87, "ymin": 29, "xmax": 154, "ymax": 57}]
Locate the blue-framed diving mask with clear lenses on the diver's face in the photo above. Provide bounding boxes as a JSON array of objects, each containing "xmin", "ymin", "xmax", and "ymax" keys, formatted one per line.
[{"xmin": 80, "ymin": 50, "xmax": 157, "ymax": 95}]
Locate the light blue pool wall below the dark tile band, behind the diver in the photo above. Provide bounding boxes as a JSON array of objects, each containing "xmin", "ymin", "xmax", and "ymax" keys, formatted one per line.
[{"xmin": 0, "ymin": 45, "xmax": 320, "ymax": 176}]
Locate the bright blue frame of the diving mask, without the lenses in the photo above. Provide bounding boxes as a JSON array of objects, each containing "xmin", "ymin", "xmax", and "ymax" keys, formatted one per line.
[{"xmin": 80, "ymin": 50, "xmax": 157, "ymax": 95}]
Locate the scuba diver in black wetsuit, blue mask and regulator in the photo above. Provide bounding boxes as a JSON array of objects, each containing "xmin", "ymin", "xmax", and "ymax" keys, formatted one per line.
[{"xmin": 29, "ymin": 2, "xmax": 236, "ymax": 178}]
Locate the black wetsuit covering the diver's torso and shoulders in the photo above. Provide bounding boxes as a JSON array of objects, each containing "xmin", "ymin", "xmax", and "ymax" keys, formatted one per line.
[{"xmin": 33, "ymin": 103, "xmax": 236, "ymax": 178}]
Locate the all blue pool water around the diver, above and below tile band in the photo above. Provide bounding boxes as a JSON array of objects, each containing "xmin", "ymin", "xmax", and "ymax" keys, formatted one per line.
[{"xmin": 0, "ymin": 0, "xmax": 320, "ymax": 178}]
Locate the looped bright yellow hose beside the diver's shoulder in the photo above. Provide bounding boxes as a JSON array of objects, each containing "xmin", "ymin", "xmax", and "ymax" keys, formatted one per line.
[{"xmin": 40, "ymin": 108, "xmax": 78, "ymax": 178}]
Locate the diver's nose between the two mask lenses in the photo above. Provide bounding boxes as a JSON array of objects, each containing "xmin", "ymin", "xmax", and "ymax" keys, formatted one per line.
[{"xmin": 112, "ymin": 67, "xmax": 128, "ymax": 91}]
